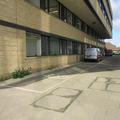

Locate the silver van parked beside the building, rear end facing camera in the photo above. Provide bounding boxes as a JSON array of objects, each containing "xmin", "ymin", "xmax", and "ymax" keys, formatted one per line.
[{"xmin": 84, "ymin": 48, "xmax": 102, "ymax": 61}]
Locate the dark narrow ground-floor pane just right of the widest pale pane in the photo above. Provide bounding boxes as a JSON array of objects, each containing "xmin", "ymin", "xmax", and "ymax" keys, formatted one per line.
[{"xmin": 41, "ymin": 35, "xmax": 50, "ymax": 56}]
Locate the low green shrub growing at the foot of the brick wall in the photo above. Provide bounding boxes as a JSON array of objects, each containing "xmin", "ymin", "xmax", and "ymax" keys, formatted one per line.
[{"xmin": 12, "ymin": 68, "xmax": 31, "ymax": 79}]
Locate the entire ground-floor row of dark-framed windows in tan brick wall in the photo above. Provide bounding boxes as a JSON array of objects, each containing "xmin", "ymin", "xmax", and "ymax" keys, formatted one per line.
[{"xmin": 26, "ymin": 32, "xmax": 82, "ymax": 57}]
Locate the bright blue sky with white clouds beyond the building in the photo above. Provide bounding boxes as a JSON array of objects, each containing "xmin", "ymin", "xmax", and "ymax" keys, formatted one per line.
[{"xmin": 106, "ymin": 0, "xmax": 120, "ymax": 47}]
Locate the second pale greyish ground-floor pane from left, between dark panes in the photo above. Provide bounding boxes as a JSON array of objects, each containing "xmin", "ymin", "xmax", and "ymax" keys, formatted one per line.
[{"xmin": 50, "ymin": 37, "xmax": 59, "ymax": 55}]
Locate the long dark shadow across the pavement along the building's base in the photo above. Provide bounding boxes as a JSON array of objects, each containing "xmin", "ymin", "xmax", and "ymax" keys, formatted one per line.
[{"xmin": 0, "ymin": 56, "xmax": 120, "ymax": 89}]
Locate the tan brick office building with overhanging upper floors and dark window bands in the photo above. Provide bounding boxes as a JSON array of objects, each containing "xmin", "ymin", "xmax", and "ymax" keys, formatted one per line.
[{"xmin": 0, "ymin": 0, "xmax": 113, "ymax": 75}]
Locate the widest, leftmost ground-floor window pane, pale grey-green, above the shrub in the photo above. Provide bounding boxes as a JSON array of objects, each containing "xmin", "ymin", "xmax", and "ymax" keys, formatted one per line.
[{"xmin": 26, "ymin": 32, "xmax": 41, "ymax": 57}]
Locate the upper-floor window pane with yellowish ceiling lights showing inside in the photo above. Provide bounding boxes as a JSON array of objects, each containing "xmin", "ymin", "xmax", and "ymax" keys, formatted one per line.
[{"xmin": 49, "ymin": 0, "xmax": 59, "ymax": 17}]
